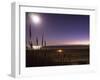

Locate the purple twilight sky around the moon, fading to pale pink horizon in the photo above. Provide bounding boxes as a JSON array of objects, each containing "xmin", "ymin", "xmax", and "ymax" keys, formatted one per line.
[{"xmin": 26, "ymin": 12, "xmax": 89, "ymax": 45}]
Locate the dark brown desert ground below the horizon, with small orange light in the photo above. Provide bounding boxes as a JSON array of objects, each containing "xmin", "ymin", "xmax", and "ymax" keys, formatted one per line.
[{"xmin": 26, "ymin": 45, "xmax": 89, "ymax": 67}]
